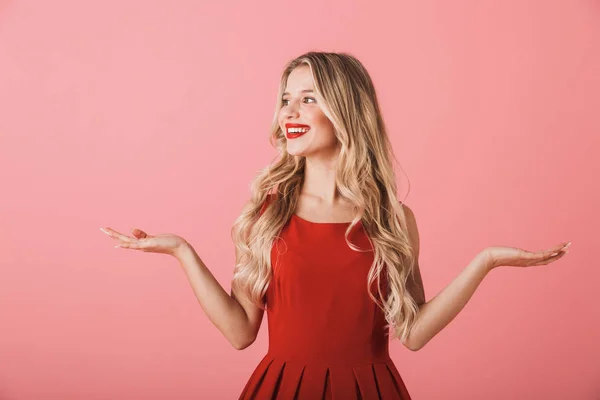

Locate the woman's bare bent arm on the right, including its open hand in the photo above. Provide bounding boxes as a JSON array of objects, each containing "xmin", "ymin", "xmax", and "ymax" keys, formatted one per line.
[{"xmin": 403, "ymin": 205, "xmax": 570, "ymax": 351}]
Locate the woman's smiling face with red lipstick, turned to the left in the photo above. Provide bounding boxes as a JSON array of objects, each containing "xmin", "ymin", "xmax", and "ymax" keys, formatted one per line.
[{"xmin": 278, "ymin": 65, "xmax": 338, "ymax": 157}]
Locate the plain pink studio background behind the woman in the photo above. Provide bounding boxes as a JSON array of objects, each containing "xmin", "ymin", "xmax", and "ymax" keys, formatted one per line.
[{"xmin": 0, "ymin": 0, "xmax": 600, "ymax": 400}]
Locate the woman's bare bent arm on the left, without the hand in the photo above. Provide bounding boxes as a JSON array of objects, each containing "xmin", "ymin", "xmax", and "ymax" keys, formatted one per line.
[{"xmin": 177, "ymin": 202, "xmax": 264, "ymax": 350}]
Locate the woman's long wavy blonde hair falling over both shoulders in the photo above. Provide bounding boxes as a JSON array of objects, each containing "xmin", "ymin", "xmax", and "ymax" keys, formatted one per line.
[{"xmin": 232, "ymin": 52, "xmax": 418, "ymax": 341}]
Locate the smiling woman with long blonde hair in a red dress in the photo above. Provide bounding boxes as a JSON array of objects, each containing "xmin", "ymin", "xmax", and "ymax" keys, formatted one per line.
[{"xmin": 104, "ymin": 52, "xmax": 570, "ymax": 400}]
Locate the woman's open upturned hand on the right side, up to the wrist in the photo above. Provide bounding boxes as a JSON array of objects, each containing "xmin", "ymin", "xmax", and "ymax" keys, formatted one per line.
[{"xmin": 484, "ymin": 242, "xmax": 571, "ymax": 269}]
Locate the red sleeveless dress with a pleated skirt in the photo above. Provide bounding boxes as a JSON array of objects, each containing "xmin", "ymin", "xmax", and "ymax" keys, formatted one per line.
[{"xmin": 239, "ymin": 195, "xmax": 410, "ymax": 400}]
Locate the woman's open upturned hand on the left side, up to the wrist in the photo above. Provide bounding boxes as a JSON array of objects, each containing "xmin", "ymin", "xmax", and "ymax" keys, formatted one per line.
[{"xmin": 100, "ymin": 228, "xmax": 188, "ymax": 257}]
